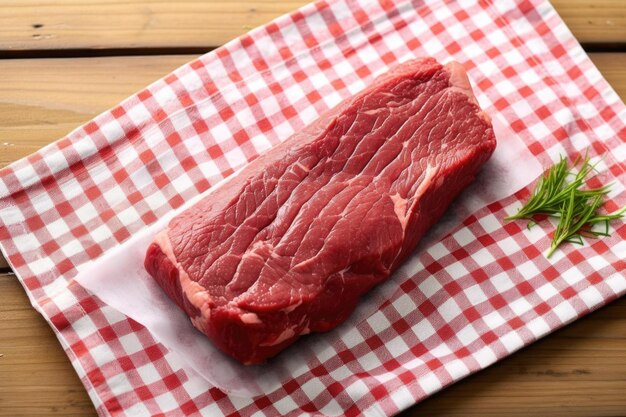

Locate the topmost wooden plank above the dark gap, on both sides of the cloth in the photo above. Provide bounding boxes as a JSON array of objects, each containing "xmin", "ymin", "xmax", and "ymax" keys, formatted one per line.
[{"xmin": 0, "ymin": 0, "xmax": 626, "ymax": 51}]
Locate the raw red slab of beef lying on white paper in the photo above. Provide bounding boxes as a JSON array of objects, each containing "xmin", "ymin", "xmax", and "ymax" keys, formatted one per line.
[{"xmin": 145, "ymin": 58, "xmax": 496, "ymax": 364}]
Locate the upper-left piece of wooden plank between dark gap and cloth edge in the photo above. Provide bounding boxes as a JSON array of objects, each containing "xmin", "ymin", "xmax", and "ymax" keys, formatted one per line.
[{"xmin": 0, "ymin": 55, "xmax": 195, "ymax": 167}]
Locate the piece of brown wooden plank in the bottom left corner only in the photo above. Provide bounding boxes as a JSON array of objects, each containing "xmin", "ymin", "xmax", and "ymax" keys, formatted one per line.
[{"xmin": 0, "ymin": 274, "xmax": 97, "ymax": 417}]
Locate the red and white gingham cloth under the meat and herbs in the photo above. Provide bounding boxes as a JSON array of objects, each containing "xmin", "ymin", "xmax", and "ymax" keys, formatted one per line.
[{"xmin": 0, "ymin": 0, "xmax": 626, "ymax": 416}]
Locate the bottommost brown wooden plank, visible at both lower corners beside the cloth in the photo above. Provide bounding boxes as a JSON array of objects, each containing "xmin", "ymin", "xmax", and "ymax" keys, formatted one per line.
[{"xmin": 0, "ymin": 268, "xmax": 626, "ymax": 417}]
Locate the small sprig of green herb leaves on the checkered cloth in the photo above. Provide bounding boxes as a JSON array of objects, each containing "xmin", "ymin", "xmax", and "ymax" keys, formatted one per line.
[{"xmin": 505, "ymin": 156, "xmax": 626, "ymax": 258}]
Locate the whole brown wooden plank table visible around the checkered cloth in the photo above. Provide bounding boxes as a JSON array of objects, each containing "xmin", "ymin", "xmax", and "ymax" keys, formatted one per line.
[{"xmin": 0, "ymin": 0, "xmax": 626, "ymax": 417}]
